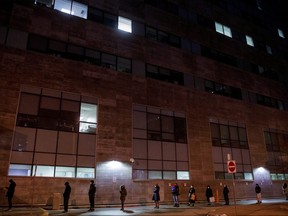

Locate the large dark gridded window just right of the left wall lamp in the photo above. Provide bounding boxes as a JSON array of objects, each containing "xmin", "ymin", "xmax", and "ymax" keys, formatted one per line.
[{"xmin": 133, "ymin": 105, "xmax": 189, "ymax": 179}]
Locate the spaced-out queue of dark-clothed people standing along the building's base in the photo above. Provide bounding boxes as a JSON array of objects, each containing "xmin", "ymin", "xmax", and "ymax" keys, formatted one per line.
[{"xmin": 6, "ymin": 179, "xmax": 288, "ymax": 213}]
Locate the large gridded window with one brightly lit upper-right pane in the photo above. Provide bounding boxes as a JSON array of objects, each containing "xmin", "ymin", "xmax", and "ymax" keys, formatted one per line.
[{"xmin": 9, "ymin": 86, "xmax": 98, "ymax": 178}]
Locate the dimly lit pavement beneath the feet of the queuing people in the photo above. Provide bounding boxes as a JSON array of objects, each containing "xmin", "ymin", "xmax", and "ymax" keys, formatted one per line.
[{"xmin": 0, "ymin": 199, "xmax": 288, "ymax": 216}]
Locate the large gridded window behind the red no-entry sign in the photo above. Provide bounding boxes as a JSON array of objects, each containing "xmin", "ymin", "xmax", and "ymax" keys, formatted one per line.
[{"xmin": 210, "ymin": 119, "xmax": 253, "ymax": 180}]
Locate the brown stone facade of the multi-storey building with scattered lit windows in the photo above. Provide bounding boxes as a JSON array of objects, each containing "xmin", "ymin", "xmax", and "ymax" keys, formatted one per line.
[{"xmin": 0, "ymin": 0, "xmax": 288, "ymax": 205}]
